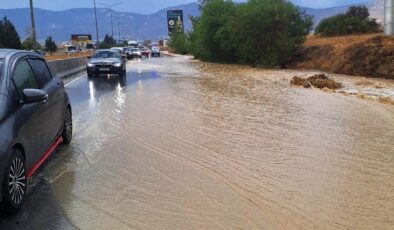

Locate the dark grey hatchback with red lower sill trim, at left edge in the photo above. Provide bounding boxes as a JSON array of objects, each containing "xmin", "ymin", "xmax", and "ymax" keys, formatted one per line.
[{"xmin": 0, "ymin": 49, "xmax": 72, "ymax": 213}]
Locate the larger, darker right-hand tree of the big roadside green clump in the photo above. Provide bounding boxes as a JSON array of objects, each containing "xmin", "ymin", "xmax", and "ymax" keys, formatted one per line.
[{"xmin": 230, "ymin": 0, "xmax": 313, "ymax": 67}]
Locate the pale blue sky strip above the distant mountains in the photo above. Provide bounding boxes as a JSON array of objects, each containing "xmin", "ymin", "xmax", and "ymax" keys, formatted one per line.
[{"xmin": 0, "ymin": 0, "xmax": 368, "ymax": 14}]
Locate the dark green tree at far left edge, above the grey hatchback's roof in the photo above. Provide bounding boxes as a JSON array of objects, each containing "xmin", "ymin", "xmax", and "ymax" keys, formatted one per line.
[{"xmin": 0, "ymin": 17, "xmax": 22, "ymax": 49}]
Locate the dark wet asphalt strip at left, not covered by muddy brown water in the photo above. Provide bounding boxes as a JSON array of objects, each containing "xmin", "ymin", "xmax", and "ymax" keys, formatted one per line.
[{"xmin": 0, "ymin": 57, "xmax": 171, "ymax": 230}]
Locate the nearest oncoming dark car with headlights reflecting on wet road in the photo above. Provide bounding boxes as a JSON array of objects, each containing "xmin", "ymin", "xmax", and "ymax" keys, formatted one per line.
[{"xmin": 87, "ymin": 49, "xmax": 126, "ymax": 78}]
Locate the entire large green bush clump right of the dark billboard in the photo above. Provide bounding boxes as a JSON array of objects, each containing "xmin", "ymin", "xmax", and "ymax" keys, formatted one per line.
[{"xmin": 173, "ymin": 0, "xmax": 313, "ymax": 67}]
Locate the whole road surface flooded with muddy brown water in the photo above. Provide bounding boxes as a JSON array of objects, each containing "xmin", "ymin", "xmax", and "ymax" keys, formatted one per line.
[{"xmin": 0, "ymin": 57, "xmax": 394, "ymax": 229}]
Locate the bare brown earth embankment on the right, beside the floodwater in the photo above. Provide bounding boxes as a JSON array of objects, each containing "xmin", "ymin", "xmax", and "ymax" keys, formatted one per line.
[{"xmin": 286, "ymin": 35, "xmax": 394, "ymax": 79}]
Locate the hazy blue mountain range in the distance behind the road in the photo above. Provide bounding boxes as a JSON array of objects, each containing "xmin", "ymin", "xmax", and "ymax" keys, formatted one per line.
[{"xmin": 0, "ymin": 0, "xmax": 381, "ymax": 41}]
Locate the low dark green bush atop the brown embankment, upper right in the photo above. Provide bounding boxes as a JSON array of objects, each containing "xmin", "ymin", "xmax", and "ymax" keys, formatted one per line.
[{"xmin": 315, "ymin": 6, "xmax": 379, "ymax": 37}]
